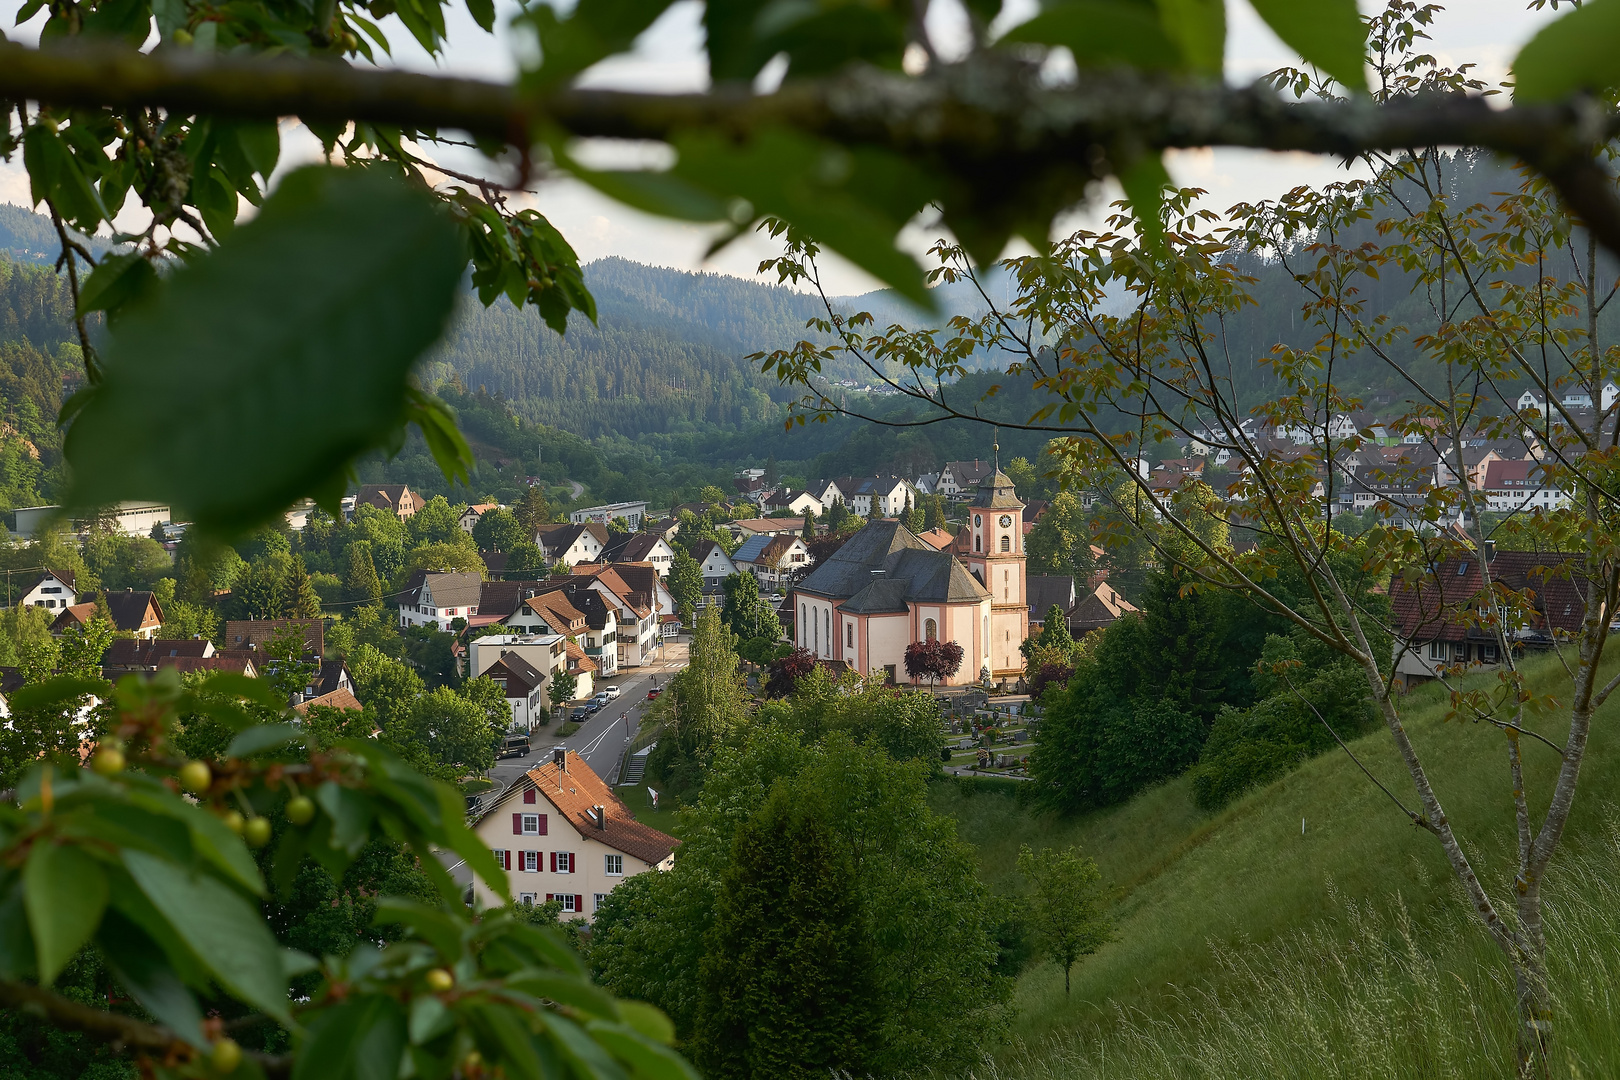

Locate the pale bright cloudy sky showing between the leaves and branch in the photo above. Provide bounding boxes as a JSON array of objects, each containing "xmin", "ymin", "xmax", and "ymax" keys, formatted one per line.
[{"xmin": 0, "ymin": 0, "xmax": 1554, "ymax": 295}]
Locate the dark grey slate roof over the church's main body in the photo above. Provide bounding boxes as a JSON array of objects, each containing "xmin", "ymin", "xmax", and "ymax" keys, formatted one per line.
[{"xmin": 797, "ymin": 520, "xmax": 990, "ymax": 614}]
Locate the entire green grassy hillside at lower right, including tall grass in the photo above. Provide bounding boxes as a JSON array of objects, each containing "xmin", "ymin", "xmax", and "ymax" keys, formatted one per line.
[{"xmin": 933, "ymin": 656, "xmax": 1620, "ymax": 1078}]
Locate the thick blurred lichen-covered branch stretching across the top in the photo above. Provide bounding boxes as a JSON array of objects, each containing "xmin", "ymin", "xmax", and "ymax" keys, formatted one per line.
[{"xmin": 0, "ymin": 42, "xmax": 1620, "ymax": 251}]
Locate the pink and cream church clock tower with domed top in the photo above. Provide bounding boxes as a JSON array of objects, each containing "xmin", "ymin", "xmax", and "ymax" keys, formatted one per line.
[{"xmin": 959, "ymin": 468, "xmax": 1029, "ymax": 680}]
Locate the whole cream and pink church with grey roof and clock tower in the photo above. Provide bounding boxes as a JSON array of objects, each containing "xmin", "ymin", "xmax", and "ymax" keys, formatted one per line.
[{"xmin": 787, "ymin": 470, "xmax": 1029, "ymax": 687}]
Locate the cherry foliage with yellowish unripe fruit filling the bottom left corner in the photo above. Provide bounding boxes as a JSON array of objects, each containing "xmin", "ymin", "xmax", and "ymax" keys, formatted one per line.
[{"xmin": 0, "ymin": 672, "xmax": 692, "ymax": 1080}]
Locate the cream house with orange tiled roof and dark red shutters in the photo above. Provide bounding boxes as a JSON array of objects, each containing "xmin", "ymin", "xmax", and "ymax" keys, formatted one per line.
[{"xmin": 471, "ymin": 746, "xmax": 680, "ymax": 921}]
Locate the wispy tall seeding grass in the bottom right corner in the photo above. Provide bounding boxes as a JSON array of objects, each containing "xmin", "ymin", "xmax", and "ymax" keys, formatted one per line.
[{"xmin": 974, "ymin": 811, "xmax": 1620, "ymax": 1080}]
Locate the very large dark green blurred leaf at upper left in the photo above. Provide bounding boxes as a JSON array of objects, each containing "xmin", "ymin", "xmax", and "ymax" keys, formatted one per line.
[{"xmin": 65, "ymin": 167, "xmax": 467, "ymax": 534}]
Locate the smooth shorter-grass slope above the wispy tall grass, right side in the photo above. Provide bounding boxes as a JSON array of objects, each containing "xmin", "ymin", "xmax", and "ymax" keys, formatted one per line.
[{"xmin": 933, "ymin": 657, "xmax": 1620, "ymax": 1041}]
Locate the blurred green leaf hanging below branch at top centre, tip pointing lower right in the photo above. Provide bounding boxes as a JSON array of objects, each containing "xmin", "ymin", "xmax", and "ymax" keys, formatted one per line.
[{"xmin": 672, "ymin": 128, "xmax": 936, "ymax": 311}]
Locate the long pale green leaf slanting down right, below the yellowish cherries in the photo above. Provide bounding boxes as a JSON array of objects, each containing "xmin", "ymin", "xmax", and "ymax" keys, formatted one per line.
[{"xmin": 122, "ymin": 850, "xmax": 292, "ymax": 1025}]
